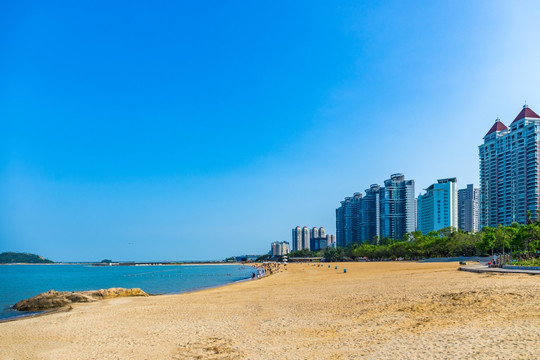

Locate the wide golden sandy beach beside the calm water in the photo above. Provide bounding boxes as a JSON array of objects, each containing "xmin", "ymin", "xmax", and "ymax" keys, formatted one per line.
[{"xmin": 0, "ymin": 262, "xmax": 540, "ymax": 360}]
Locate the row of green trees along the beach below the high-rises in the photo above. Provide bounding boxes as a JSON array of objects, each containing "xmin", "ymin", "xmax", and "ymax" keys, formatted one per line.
[{"xmin": 282, "ymin": 222, "xmax": 540, "ymax": 261}]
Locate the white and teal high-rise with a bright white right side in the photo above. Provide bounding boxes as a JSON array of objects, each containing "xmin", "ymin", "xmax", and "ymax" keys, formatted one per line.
[{"xmin": 417, "ymin": 178, "xmax": 458, "ymax": 234}]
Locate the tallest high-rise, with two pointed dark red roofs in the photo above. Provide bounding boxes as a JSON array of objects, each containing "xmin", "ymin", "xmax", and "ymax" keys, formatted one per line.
[{"xmin": 479, "ymin": 105, "xmax": 540, "ymax": 228}]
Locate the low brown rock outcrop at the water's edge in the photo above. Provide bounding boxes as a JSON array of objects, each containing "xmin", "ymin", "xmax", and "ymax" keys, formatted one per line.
[{"xmin": 13, "ymin": 288, "xmax": 148, "ymax": 311}]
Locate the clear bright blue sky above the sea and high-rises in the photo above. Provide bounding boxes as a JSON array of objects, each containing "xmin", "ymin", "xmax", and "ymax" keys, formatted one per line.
[{"xmin": 0, "ymin": 0, "xmax": 540, "ymax": 261}]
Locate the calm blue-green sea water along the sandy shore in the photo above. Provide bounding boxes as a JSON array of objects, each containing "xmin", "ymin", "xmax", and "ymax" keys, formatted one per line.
[{"xmin": 0, "ymin": 265, "xmax": 254, "ymax": 318}]
